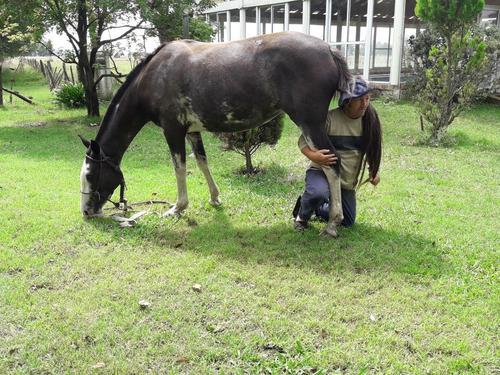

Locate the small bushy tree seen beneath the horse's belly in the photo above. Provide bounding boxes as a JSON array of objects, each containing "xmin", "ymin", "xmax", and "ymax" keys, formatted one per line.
[{"xmin": 215, "ymin": 115, "xmax": 283, "ymax": 174}]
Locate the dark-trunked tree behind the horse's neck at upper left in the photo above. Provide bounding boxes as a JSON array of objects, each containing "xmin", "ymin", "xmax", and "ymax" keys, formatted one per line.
[{"xmin": 39, "ymin": 0, "xmax": 144, "ymax": 116}]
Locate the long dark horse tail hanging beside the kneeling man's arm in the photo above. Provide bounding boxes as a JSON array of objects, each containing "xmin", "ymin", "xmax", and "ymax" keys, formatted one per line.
[{"xmin": 358, "ymin": 104, "xmax": 382, "ymax": 187}]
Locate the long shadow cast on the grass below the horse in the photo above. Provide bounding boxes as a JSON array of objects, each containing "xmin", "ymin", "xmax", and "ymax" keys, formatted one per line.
[{"xmin": 89, "ymin": 208, "xmax": 445, "ymax": 277}]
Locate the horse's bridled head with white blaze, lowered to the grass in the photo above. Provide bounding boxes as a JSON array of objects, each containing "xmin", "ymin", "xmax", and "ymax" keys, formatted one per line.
[{"xmin": 80, "ymin": 136, "xmax": 124, "ymax": 217}]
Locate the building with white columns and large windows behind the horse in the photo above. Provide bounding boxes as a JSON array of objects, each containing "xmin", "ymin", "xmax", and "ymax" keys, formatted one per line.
[{"xmin": 206, "ymin": 0, "xmax": 500, "ymax": 90}]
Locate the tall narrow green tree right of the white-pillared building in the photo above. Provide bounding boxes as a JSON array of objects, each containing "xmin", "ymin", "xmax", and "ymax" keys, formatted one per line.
[{"xmin": 415, "ymin": 0, "xmax": 486, "ymax": 145}]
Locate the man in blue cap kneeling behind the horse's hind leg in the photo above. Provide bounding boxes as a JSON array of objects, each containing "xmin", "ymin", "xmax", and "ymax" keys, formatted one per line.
[{"xmin": 293, "ymin": 77, "xmax": 382, "ymax": 230}]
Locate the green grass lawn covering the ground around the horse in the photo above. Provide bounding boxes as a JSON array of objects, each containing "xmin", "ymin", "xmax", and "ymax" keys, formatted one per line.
[{"xmin": 0, "ymin": 64, "xmax": 500, "ymax": 374}]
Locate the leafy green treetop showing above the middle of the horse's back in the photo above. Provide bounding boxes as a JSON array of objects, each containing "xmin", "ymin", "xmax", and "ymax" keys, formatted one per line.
[{"xmin": 140, "ymin": 0, "xmax": 215, "ymax": 43}]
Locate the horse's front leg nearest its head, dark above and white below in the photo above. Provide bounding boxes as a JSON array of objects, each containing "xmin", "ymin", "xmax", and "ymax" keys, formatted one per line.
[{"xmin": 163, "ymin": 127, "xmax": 188, "ymax": 216}]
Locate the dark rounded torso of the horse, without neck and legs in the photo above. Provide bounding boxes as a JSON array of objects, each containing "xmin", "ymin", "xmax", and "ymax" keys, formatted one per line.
[{"xmin": 141, "ymin": 32, "xmax": 340, "ymax": 131}]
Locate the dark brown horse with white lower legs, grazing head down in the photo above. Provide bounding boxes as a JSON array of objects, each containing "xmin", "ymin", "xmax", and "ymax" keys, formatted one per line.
[{"xmin": 80, "ymin": 32, "xmax": 353, "ymax": 237}]
